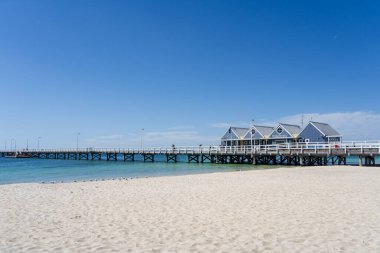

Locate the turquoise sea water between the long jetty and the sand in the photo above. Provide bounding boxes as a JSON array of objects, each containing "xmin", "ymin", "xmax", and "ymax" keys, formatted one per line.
[{"xmin": 0, "ymin": 158, "xmax": 273, "ymax": 184}]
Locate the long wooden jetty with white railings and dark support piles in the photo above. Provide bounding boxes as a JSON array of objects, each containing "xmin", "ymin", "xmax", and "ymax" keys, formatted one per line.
[{"xmin": 0, "ymin": 141, "xmax": 380, "ymax": 166}]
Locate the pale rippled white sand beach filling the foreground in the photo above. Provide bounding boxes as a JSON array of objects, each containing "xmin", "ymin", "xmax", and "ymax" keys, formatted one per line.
[{"xmin": 0, "ymin": 167, "xmax": 380, "ymax": 253}]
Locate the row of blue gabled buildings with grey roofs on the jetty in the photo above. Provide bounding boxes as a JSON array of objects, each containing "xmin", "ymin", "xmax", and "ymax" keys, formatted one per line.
[{"xmin": 221, "ymin": 121, "xmax": 342, "ymax": 146}]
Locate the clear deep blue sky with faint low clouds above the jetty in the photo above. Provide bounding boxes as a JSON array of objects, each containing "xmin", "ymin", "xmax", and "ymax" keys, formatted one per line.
[{"xmin": 0, "ymin": 0, "xmax": 380, "ymax": 148}]
